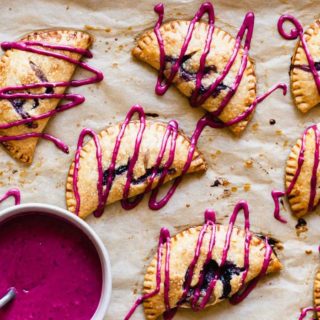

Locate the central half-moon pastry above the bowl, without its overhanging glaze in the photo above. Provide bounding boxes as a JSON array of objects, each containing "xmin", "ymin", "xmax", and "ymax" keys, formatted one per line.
[{"xmin": 66, "ymin": 120, "xmax": 206, "ymax": 218}]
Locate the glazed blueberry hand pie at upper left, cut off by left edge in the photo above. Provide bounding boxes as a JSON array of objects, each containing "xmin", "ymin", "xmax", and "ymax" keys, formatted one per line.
[{"xmin": 0, "ymin": 30, "xmax": 102, "ymax": 163}]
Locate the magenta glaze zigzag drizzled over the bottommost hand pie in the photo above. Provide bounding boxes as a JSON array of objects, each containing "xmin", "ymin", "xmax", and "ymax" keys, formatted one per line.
[{"xmin": 124, "ymin": 201, "xmax": 272, "ymax": 320}]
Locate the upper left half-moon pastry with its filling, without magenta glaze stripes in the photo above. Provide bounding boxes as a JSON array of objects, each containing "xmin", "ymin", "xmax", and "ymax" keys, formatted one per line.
[{"xmin": 0, "ymin": 30, "xmax": 92, "ymax": 163}]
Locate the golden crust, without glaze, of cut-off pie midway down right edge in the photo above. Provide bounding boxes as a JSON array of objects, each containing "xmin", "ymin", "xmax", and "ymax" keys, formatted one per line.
[{"xmin": 285, "ymin": 126, "xmax": 320, "ymax": 217}]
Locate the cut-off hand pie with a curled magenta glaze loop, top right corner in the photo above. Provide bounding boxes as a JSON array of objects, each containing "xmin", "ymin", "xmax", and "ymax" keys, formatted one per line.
[{"xmin": 278, "ymin": 15, "xmax": 320, "ymax": 112}]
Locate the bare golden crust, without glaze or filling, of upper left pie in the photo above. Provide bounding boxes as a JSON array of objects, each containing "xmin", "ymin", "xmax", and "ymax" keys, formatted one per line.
[{"xmin": 0, "ymin": 30, "xmax": 92, "ymax": 163}]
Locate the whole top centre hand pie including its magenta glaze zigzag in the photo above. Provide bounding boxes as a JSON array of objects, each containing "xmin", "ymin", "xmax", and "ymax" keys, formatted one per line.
[{"xmin": 132, "ymin": 2, "xmax": 256, "ymax": 134}]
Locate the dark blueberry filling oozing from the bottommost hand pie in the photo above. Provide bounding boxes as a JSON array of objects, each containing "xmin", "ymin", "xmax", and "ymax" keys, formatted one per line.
[{"xmin": 184, "ymin": 260, "xmax": 245, "ymax": 301}]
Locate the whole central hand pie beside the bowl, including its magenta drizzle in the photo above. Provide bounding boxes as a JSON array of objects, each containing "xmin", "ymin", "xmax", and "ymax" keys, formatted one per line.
[{"xmin": 66, "ymin": 106, "xmax": 206, "ymax": 218}]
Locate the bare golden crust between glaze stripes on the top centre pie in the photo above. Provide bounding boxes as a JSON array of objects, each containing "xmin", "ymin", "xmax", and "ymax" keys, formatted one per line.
[{"xmin": 132, "ymin": 20, "xmax": 256, "ymax": 134}]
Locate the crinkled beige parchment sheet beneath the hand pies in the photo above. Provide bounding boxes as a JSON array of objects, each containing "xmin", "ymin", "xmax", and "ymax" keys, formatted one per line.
[{"xmin": 0, "ymin": 0, "xmax": 320, "ymax": 320}]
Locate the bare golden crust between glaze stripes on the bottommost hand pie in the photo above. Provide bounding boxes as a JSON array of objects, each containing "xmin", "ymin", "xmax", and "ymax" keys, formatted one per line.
[{"xmin": 144, "ymin": 225, "xmax": 282, "ymax": 320}]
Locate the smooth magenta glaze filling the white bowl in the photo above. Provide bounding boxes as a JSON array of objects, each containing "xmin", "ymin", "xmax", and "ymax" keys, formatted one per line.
[{"xmin": 0, "ymin": 212, "xmax": 102, "ymax": 320}]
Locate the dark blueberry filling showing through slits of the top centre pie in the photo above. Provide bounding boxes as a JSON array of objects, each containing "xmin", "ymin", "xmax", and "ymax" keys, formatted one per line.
[{"xmin": 165, "ymin": 53, "xmax": 230, "ymax": 98}]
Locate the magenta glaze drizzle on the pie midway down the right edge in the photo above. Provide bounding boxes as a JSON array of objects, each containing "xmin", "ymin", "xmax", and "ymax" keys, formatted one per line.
[{"xmin": 271, "ymin": 124, "xmax": 320, "ymax": 223}]
